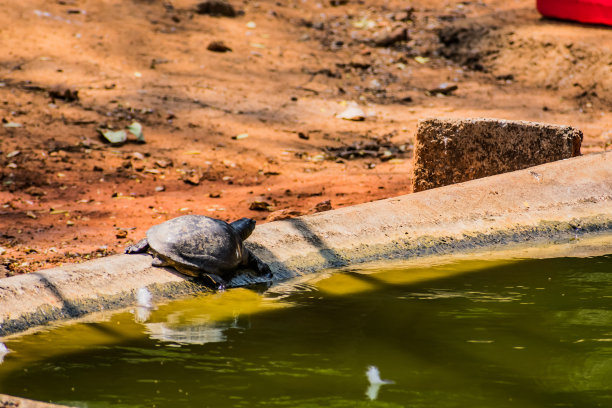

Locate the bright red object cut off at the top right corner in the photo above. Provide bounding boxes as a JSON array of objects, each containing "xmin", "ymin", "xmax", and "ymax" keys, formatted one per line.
[{"xmin": 537, "ymin": 0, "xmax": 612, "ymax": 25}]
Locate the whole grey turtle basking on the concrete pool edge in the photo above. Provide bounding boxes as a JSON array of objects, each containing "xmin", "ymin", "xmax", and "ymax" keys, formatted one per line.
[{"xmin": 125, "ymin": 215, "xmax": 271, "ymax": 289}]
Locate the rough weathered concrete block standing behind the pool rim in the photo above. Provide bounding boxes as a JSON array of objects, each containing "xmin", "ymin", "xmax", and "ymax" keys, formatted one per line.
[{"xmin": 412, "ymin": 118, "xmax": 582, "ymax": 192}]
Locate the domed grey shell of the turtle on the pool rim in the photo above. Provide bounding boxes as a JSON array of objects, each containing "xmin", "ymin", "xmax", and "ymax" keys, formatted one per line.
[{"xmin": 147, "ymin": 215, "xmax": 245, "ymax": 274}]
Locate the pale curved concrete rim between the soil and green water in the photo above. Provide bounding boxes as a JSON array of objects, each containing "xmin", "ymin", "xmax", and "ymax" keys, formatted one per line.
[{"xmin": 0, "ymin": 152, "xmax": 612, "ymax": 336}]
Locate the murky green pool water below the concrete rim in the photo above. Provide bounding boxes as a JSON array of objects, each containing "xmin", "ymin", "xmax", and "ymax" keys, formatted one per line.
[{"xmin": 0, "ymin": 255, "xmax": 612, "ymax": 408}]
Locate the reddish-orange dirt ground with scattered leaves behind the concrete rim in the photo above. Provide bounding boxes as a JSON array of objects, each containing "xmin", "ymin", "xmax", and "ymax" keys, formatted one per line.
[{"xmin": 0, "ymin": 0, "xmax": 612, "ymax": 277}]
